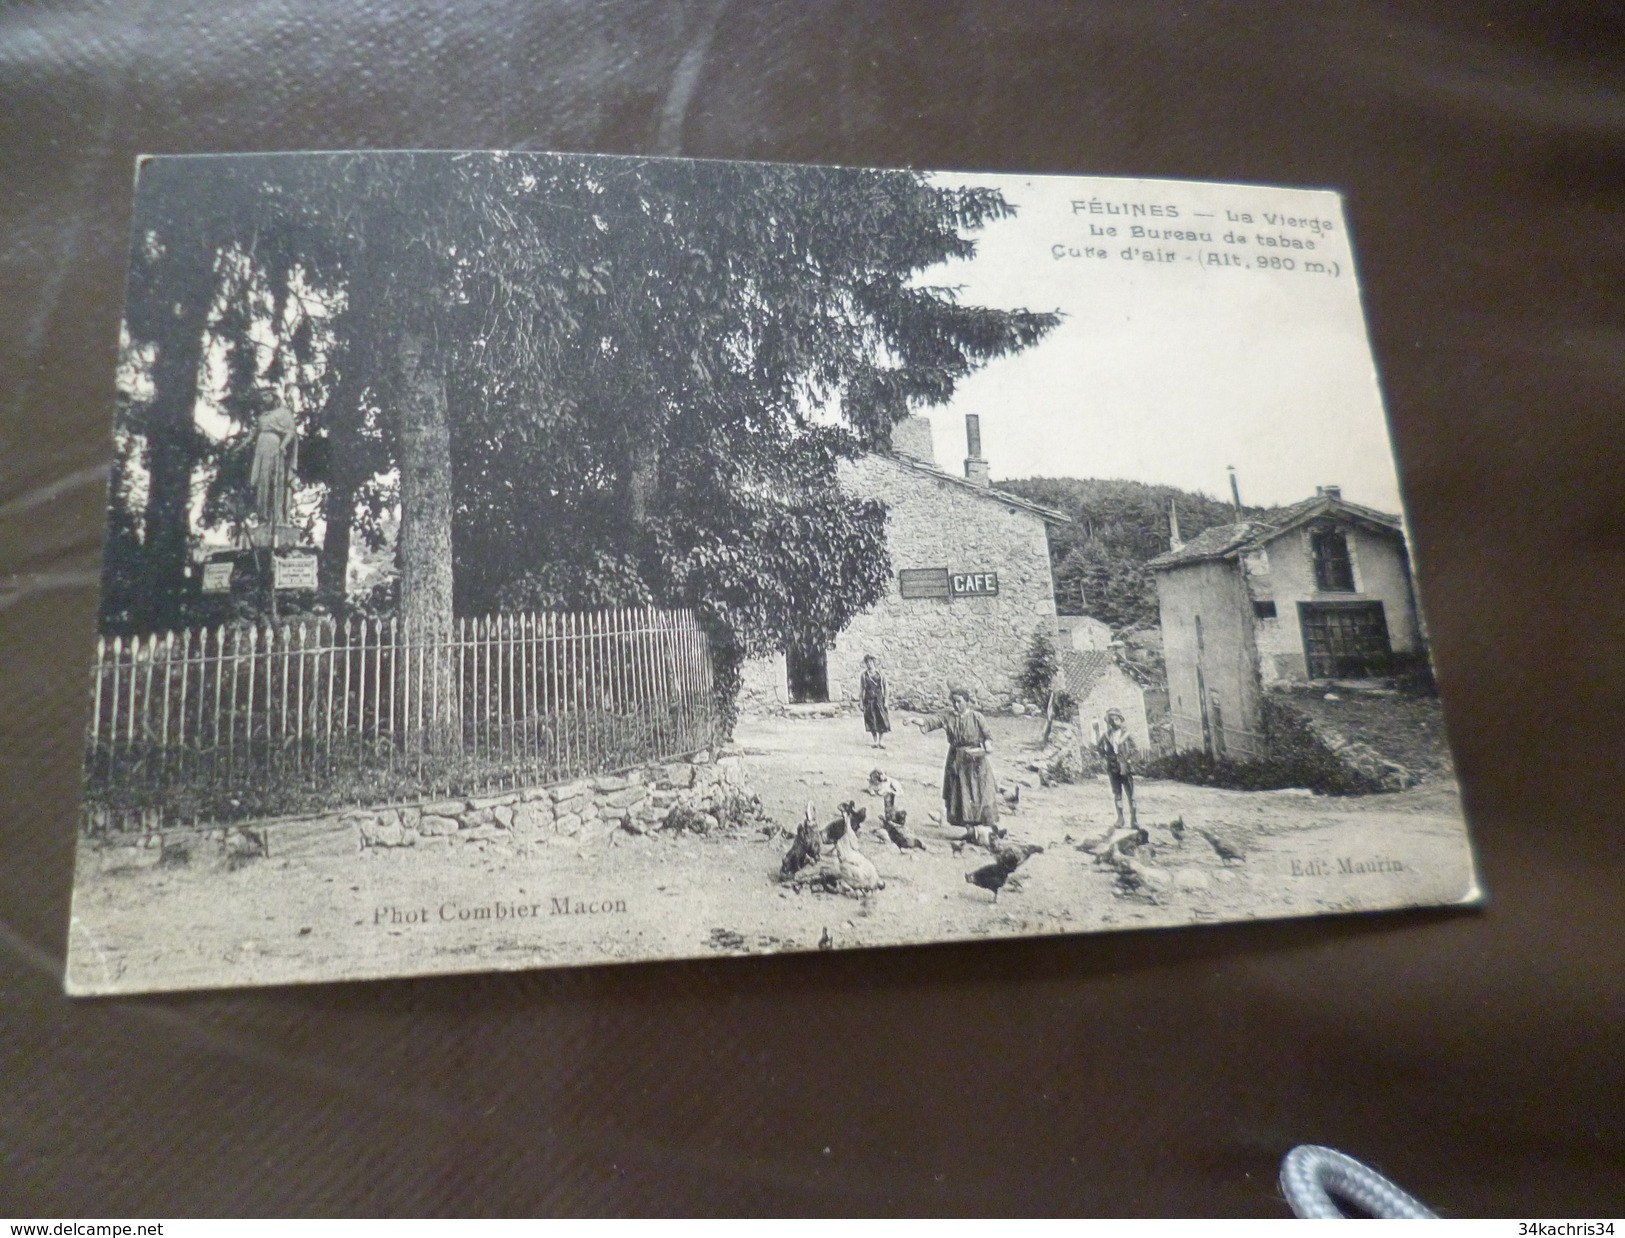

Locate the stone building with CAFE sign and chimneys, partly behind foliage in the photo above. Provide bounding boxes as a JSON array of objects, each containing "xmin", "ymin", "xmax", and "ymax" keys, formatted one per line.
[{"xmin": 739, "ymin": 414, "xmax": 1066, "ymax": 713}]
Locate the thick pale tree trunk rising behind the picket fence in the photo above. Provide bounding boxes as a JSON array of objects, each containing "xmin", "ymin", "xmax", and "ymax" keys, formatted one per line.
[{"xmin": 397, "ymin": 330, "xmax": 462, "ymax": 751}]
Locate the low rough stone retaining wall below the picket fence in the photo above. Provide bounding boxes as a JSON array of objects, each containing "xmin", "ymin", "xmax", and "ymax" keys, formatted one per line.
[{"xmin": 352, "ymin": 752, "xmax": 748, "ymax": 848}]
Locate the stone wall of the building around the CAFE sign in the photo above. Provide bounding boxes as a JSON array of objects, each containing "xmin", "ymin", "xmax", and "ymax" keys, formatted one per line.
[{"xmin": 741, "ymin": 455, "xmax": 1055, "ymax": 712}]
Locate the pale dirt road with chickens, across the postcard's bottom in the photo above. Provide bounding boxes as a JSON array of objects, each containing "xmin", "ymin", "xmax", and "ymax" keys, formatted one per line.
[{"xmin": 70, "ymin": 715, "xmax": 1474, "ymax": 993}]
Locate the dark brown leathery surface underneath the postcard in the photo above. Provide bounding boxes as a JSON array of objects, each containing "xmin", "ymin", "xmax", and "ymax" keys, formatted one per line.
[{"xmin": 0, "ymin": 0, "xmax": 1625, "ymax": 1217}]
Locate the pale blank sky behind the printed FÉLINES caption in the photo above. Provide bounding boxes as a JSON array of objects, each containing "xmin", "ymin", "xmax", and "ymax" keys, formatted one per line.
[{"xmin": 920, "ymin": 174, "xmax": 1399, "ymax": 512}]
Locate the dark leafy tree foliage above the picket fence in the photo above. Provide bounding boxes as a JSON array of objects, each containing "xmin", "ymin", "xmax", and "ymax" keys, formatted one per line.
[{"xmin": 108, "ymin": 154, "xmax": 1056, "ymax": 724}]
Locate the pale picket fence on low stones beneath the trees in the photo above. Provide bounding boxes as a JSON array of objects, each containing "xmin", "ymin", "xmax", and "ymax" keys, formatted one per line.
[{"xmin": 85, "ymin": 609, "xmax": 718, "ymax": 832}]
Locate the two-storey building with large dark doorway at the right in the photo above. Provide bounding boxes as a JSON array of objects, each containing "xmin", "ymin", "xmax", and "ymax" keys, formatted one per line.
[{"xmin": 1147, "ymin": 486, "xmax": 1425, "ymax": 757}]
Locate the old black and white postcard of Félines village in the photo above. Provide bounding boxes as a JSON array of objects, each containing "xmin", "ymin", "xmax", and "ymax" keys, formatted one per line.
[{"xmin": 67, "ymin": 151, "xmax": 1482, "ymax": 994}]
